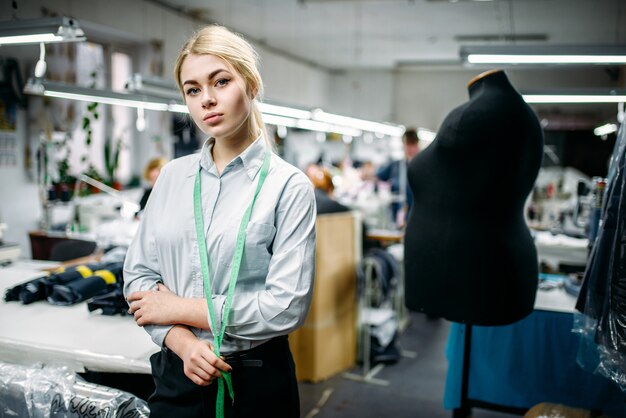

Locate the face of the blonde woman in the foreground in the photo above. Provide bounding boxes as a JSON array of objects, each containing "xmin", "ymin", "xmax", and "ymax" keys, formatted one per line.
[{"xmin": 180, "ymin": 54, "xmax": 254, "ymax": 143}]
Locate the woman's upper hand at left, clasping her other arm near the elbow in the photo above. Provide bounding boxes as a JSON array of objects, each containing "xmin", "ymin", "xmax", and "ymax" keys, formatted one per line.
[{"xmin": 128, "ymin": 283, "xmax": 183, "ymax": 327}]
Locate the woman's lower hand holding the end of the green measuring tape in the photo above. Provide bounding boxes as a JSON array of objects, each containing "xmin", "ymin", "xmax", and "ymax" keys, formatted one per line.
[{"xmin": 180, "ymin": 340, "xmax": 232, "ymax": 386}]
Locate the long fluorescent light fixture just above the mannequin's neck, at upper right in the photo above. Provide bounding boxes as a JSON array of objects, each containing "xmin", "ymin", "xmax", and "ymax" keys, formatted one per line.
[{"xmin": 461, "ymin": 45, "xmax": 626, "ymax": 64}]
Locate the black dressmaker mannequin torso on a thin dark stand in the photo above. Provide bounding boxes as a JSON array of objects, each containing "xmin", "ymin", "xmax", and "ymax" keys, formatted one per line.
[{"xmin": 404, "ymin": 70, "xmax": 543, "ymax": 414}]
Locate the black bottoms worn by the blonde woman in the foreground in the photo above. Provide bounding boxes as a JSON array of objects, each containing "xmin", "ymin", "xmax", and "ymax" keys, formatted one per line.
[{"xmin": 148, "ymin": 336, "xmax": 300, "ymax": 418}]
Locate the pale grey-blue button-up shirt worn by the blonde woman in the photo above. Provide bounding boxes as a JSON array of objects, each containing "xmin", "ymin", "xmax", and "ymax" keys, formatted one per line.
[{"xmin": 124, "ymin": 137, "xmax": 316, "ymax": 354}]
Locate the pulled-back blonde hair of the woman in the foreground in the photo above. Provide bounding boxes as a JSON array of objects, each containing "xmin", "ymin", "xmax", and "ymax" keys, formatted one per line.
[{"xmin": 174, "ymin": 25, "xmax": 274, "ymax": 149}]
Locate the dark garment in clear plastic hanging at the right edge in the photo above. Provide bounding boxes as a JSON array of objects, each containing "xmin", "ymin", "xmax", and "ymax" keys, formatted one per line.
[{"xmin": 575, "ymin": 122, "xmax": 626, "ymax": 391}]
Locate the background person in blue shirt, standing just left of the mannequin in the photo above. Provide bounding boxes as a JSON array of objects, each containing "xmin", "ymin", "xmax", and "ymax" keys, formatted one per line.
[{"xmin": 376, "ymin": 128, "xmax": 419, "ymax": 226}]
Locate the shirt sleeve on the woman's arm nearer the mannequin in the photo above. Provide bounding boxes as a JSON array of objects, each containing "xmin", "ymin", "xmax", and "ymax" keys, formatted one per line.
[{"xmin": 222, "ymin": 176, "xmax": 316, "ymax": 340}]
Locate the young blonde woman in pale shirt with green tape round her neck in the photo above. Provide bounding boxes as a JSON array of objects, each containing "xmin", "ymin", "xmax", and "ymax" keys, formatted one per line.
[{"xmin": 124, "ymin": 26, "xmax": 316, "ymax": 418}]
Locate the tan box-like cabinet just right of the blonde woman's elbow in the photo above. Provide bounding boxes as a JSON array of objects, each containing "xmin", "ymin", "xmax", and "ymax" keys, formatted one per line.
[{"xmin": 289, "ymin": 212, "xmax": 361, "ymax": 382}]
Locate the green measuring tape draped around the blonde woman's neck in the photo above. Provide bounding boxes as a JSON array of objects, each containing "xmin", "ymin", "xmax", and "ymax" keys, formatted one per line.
[{"xmin": 193, "ymin": 151, "xmax": 271, "ymax": 418}]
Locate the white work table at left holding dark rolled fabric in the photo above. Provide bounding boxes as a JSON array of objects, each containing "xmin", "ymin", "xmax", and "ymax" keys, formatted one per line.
[{"xmin": 0, "ymin": 261, "xmax": 159, "ymax": 374}]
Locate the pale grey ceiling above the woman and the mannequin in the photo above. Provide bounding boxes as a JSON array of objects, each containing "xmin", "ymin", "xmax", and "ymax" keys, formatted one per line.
[{"xmin": 149, "ymin": 0, "xmax": 626, "ymax": 71}]
